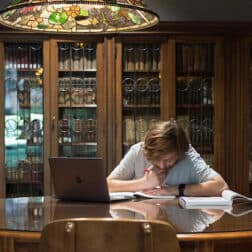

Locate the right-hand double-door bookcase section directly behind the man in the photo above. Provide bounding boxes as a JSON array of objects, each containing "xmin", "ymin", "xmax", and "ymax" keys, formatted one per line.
[{"xmin": 116, "ymin": 37, "xmax": 224, "ymax": 177}]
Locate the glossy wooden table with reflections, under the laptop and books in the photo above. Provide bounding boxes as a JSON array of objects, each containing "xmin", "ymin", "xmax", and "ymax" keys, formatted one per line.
[{"xmin": 0, "ymin": 197, "xmax": 252, "ymax": 252}]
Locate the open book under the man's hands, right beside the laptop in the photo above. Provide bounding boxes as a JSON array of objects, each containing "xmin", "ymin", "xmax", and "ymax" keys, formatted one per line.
[{"xmin": 109, "ymin": 192, "xmax": 176, "ymax": 199}]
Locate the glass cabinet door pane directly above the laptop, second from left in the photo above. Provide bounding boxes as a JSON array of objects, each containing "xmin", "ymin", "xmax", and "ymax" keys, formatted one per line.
[{"xmin": 57, "ymin": 42, "xmax": 97, "ymax": 157}]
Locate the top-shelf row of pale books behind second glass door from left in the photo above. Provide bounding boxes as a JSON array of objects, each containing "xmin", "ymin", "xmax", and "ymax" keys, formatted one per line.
[{"xmin": 58, "ymin": 44, "xmax": 96, "ymax": 70}]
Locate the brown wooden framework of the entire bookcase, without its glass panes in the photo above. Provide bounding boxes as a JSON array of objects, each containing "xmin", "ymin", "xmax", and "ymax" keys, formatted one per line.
[{"xmin": 0, "ymin": 24, "xmax": 252, "ymax": 197}]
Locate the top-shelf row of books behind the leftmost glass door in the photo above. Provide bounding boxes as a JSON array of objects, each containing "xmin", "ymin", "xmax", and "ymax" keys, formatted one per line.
[{"xmin": 4, "ymin": 43, "xmax": 42, "ymax": 69}]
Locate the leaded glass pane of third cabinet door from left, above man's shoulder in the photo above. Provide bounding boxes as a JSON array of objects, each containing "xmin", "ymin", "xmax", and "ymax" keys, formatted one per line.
[{"xmin": 121, "ymin": 43, "xmax": 161, "ymax": 155}]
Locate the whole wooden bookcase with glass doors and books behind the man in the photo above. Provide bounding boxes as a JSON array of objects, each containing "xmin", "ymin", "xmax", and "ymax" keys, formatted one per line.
[{"xmin": 0, "ymin": 28, "xmax": 251, "ymax": 196}]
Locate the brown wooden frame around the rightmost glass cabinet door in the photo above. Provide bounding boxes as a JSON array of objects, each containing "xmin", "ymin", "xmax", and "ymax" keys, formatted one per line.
[{"xmin": 166, "ymin": 36, "xmax": 225, "ymax": 176}]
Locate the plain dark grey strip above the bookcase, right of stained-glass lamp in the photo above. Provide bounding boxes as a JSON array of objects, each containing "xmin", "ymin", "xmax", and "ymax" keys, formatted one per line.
[{"xmin": 144, "ymin": 0, "xmax": 252, "ymax": 22}]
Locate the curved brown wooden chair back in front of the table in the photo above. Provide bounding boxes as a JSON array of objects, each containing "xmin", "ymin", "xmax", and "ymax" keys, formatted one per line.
[{"xmin": 40, "ymin": 218, "xmax": 180, "ymax": 252}]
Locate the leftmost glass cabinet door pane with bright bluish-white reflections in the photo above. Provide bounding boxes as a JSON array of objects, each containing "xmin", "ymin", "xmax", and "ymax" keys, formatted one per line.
[{"xmin": 4, "ymin": 43, "xmax": 44, "ymax": 197}]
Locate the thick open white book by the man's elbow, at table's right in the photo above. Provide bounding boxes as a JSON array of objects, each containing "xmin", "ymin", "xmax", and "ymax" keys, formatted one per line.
[{"xmin": 179, "ymin": 190, "xmax": 252, "ymax": 209}]
